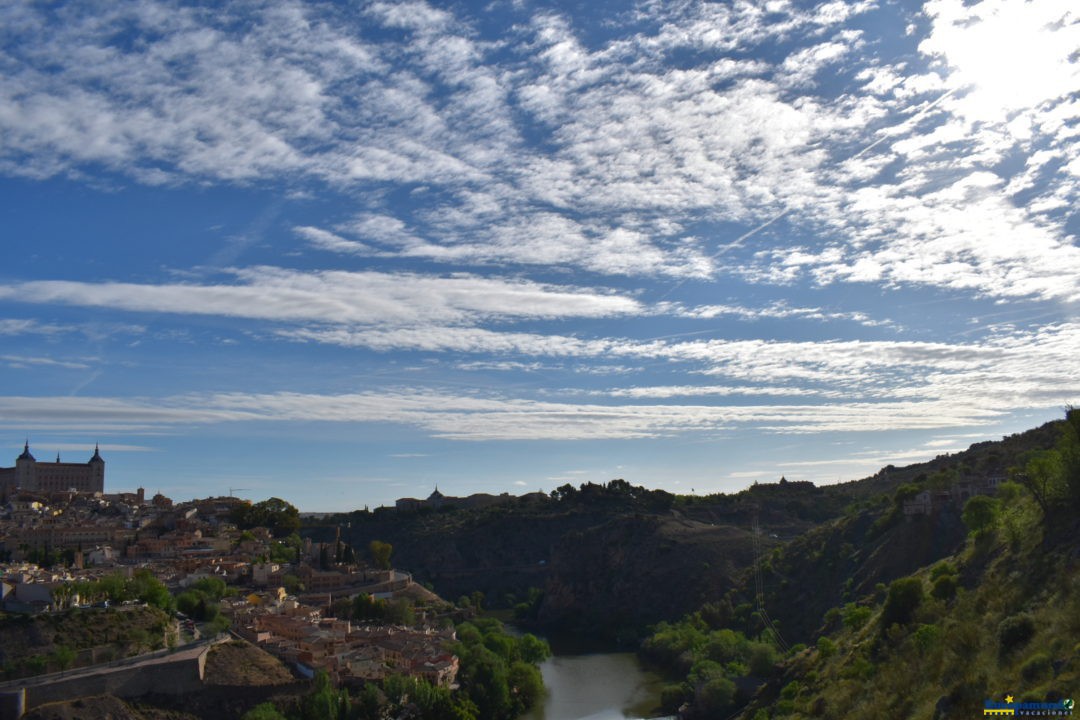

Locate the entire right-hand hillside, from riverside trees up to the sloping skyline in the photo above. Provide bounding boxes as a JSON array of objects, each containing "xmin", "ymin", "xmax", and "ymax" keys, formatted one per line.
[{"xmin": 643, "ymin": 410, "xmax": 1080, "ymax": 720}]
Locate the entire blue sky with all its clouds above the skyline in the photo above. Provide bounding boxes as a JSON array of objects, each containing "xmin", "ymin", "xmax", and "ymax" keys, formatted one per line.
[{"xmin": 0, "ymin": 0, "xmax": 1080, "ymax": 511}]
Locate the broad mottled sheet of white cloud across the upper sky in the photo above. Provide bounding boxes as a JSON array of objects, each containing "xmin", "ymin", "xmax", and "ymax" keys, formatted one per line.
[{"xmin": 0, "ymin": 0, "xmax": 1080, "ymax": 299}]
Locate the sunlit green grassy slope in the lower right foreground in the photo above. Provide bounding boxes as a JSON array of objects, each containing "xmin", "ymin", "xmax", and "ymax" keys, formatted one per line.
[{"xmin": 743, "ymin": 505, "xmax": 1080, "ymax": 720}]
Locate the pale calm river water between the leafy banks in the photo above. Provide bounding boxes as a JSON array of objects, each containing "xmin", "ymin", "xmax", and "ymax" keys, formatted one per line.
[{"xmin": 523, "ymin": 653, "xmax": 663, "ymax": 720}]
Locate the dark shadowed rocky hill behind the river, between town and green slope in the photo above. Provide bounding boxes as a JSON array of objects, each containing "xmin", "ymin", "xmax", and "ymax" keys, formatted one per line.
[{"xmin": 306, "ymin": 481, "xmax": 846, "ymax": 639}]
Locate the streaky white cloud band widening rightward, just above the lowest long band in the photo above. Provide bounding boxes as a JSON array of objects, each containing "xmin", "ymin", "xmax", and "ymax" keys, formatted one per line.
[{"xmin": 282, "ymin": 315, "xmax": 1080, "ymax": 412}]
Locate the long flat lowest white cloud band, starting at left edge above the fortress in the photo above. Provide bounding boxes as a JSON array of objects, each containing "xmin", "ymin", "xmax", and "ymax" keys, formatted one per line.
[{"xmin": 0, "ymin": 391, "xmax": 995, "ymax": 440}]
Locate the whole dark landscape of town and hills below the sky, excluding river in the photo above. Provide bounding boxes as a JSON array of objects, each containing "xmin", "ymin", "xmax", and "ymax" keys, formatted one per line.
[{"xmin": 0, "ymin": 416, "xmax": 1080, "ymax": 720}]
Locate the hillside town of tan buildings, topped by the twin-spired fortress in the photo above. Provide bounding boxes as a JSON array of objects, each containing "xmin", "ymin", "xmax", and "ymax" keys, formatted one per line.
[{"xmin": 0, "ymin": 444, "xmax": 458, "ymax": 687}]
